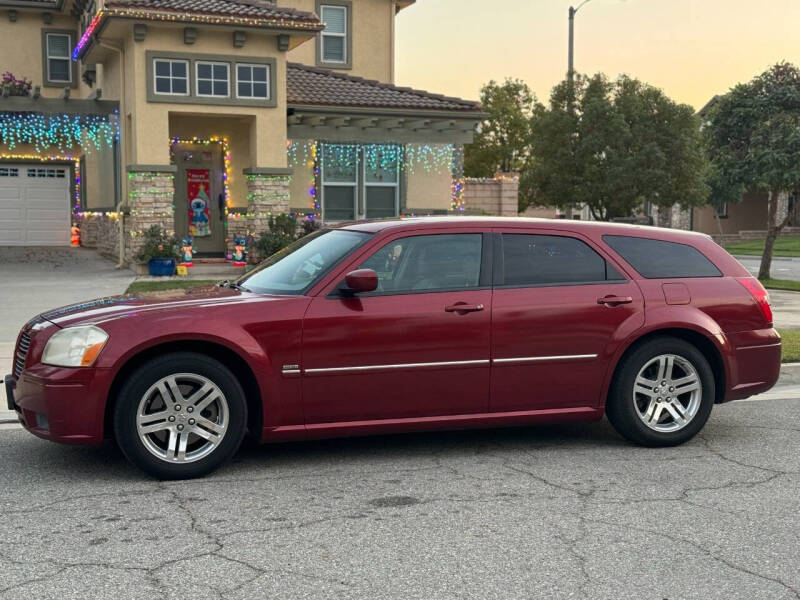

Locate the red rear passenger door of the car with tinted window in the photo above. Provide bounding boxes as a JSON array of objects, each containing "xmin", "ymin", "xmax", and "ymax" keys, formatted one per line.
[{"xmin": 491, "ymin": 229, "xmax": 644, "ymax": 412}]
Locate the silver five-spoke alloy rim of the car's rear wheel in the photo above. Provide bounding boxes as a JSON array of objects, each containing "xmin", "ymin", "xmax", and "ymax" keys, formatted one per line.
[{"xmin": 633, "ymin": 354, "xmax": 703, "ymax": 433}]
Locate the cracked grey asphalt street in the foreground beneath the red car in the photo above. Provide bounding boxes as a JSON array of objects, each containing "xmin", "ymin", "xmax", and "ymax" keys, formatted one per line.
[{"xmin": 0, "ymin": 392, "xmax": 800, "ymax": 600}]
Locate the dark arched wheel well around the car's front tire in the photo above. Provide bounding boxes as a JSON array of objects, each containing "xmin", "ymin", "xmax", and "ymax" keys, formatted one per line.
[{"xmin": 103, "ymin": 340, "xmax": 263, "ymax": 438}]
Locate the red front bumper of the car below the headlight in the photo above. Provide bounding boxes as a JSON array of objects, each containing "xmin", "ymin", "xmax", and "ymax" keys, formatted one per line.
[{"xmin": 6, "ymin": 365, "xmax": 110, "ymax": 445}]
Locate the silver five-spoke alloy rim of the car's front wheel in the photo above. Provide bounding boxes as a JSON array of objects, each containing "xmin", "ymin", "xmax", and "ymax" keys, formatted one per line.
[{"xmin": 136, "ymin": 373, "xmax": 229, "ymax": 463}]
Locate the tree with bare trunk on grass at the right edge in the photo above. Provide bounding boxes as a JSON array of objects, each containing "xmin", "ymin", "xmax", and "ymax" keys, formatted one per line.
[{"xmin": 706, "ymin": 62, "xmax": 800, "ymax": 279}]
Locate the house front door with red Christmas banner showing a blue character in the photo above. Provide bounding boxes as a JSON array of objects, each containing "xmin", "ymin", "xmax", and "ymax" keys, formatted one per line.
[{"xmin": 172, "ymin": 143, "xmax": 225, "ymax": 257}]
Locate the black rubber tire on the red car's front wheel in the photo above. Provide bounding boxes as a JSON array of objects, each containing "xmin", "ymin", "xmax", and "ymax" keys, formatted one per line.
[{"xmin": 114, "ymin": 352, "xmax": 247, "ymax": 479}]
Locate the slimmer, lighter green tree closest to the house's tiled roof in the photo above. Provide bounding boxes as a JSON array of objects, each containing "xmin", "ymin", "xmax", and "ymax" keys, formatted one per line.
[{"xmin": 464, "ymin": 79, "xmax": 536, "ymax": 206}]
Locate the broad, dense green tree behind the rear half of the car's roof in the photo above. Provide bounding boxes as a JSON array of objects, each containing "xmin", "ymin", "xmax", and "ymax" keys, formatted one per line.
[{"xmin": 526, "ymin": 74, "xmax": 708, "ymax": 225}]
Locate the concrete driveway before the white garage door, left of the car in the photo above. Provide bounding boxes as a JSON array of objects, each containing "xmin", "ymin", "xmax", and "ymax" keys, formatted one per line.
[{"xmin": 0, "ymin": 246, "xmax": 134, "ymax": 412}]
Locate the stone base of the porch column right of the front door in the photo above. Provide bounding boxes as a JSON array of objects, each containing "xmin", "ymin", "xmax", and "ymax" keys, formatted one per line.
[{"xmin": 245, "ymin": 167, "xmax": 292, "ymax": 262}]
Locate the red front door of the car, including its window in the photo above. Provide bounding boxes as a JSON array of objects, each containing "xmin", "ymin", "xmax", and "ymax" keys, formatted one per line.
[{"xmin": 302, "ymin": 229, "xmax": 492, "ymax": 425}]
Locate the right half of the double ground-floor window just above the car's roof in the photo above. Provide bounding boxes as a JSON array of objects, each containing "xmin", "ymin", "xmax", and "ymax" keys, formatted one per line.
[{"xmin": 363, "ymin": 145, "xmax": 400, "ymax": 219}]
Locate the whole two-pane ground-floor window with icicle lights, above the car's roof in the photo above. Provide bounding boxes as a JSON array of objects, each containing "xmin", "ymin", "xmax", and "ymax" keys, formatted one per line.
[{"xmin": 320, "ymin": 144, "xmax": 402, "ymax": 221}]
